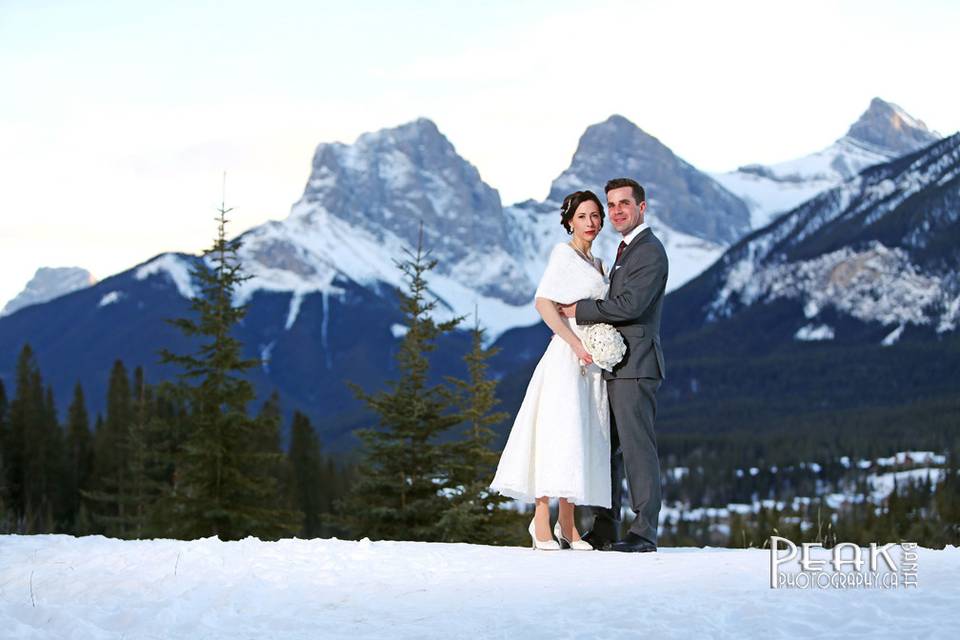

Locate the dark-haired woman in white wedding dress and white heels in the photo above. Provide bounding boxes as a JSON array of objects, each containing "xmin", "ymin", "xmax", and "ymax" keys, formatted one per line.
[{"xmin": 490, "ymin": 191, "xmax": 610, "ymax": 550}]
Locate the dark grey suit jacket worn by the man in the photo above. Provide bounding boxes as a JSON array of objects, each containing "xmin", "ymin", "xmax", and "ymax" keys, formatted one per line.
[{"xmin": 577, "ymin": 229, "xmax": 669, "ymax": 380}]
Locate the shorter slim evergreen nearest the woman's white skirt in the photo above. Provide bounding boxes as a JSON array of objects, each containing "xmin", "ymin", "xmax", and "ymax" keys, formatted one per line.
[{"xmin": 440, "ymin": 312, "xmax": 518, "ymax": 544}]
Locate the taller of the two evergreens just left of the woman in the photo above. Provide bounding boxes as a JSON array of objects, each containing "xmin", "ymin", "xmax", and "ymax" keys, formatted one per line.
[{"xmin": 340, "ymin": 224, "xmax": 461, "ymax": 540}]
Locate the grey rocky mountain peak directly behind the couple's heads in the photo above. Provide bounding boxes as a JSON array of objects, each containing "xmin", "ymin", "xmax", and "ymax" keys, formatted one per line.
[{"xmin": 547, "ymin": 115, "xmax": 750, "ymax": 243}]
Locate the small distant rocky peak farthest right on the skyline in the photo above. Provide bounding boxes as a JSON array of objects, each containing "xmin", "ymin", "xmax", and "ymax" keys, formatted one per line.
[{"xmin": 846, "ymin": 98, "xmax": 940, "ymax": 158}]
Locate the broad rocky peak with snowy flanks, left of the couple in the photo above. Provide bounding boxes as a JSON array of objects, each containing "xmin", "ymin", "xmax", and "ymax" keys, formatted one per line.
[{"xmin": 228, "ymin": 118, "xmax": 535, "ymax": 335}]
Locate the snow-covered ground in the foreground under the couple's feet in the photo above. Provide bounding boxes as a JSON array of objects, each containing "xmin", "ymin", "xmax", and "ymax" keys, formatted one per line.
[{"xmin": 0, "ymin": 535, "xmax": 960, "ymax": 640}]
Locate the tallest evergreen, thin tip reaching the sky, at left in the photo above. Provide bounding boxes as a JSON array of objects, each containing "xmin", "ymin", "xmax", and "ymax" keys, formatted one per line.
[{"xmin": 160, "ymin": 194, "xmax": 298, "ymax": 539}]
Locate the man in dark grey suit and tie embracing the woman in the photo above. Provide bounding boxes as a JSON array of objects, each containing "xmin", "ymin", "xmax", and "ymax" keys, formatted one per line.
[{"xmin": 560, "ymin": 178, "xmax": 667, "ymax": 552}]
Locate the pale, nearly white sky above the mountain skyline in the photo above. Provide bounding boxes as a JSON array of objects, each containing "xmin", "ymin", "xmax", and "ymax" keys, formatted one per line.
[{"xmin": 0, "ymin": 0, "xmax": 960, "ymax": 306}]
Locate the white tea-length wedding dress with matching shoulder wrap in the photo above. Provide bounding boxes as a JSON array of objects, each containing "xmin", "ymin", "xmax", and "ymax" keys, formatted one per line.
[{"xmin": 490, "ymin": 243, "xmax": 610, "ymax": 508}]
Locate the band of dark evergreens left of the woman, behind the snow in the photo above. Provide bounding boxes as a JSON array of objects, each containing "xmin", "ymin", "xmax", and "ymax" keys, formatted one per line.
[{"xmin": 0, "ymin": 201, "xmax": 523, "ymax": 544}]
